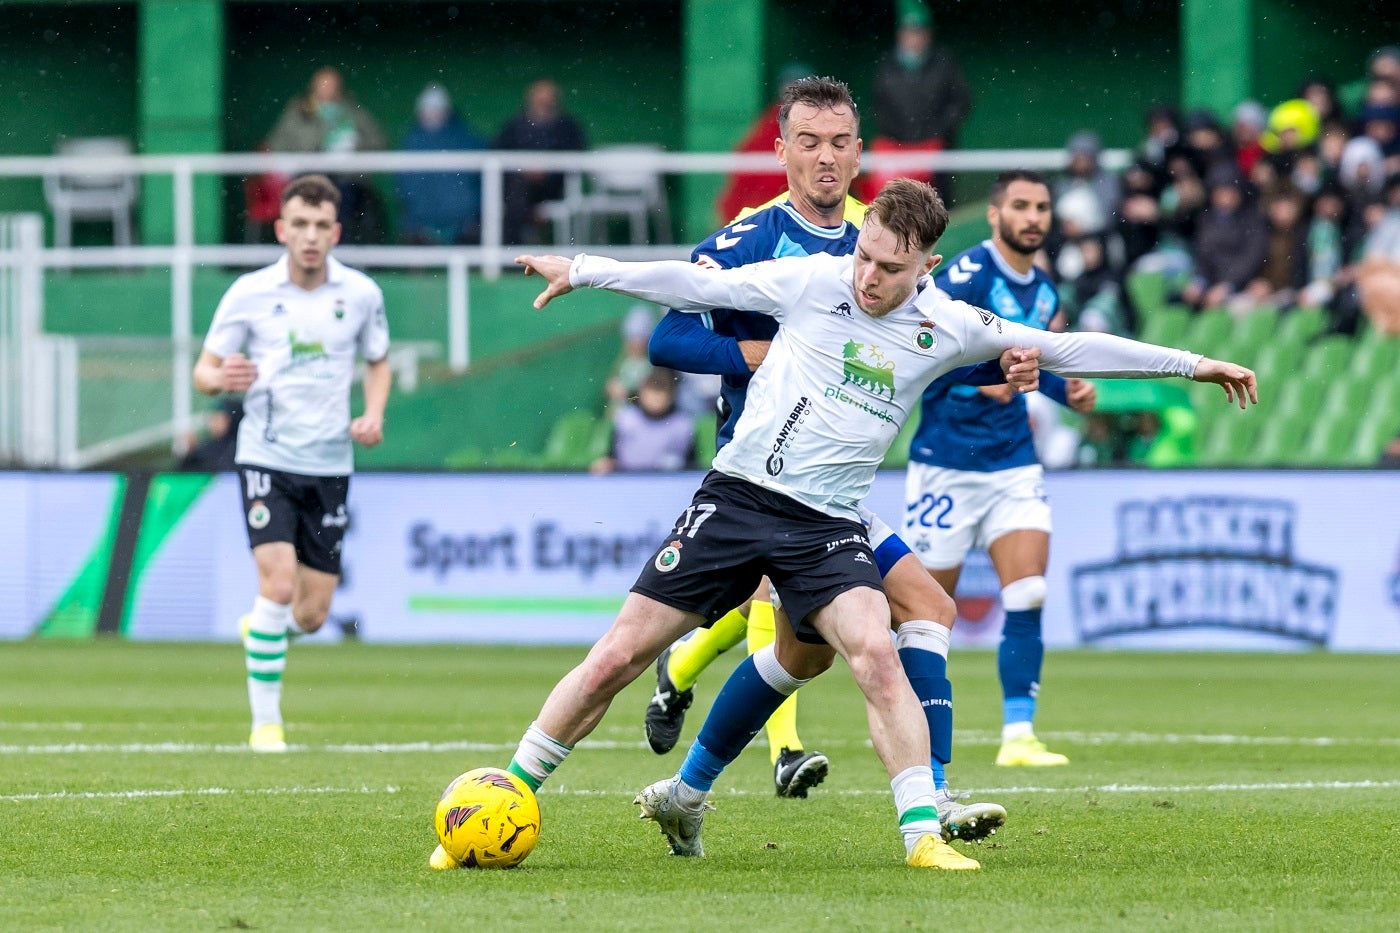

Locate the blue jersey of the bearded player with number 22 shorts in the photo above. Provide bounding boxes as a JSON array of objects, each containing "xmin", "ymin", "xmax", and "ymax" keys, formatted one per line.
[{"xmin": 909, "ymin": 240, "xmax": 1060, "ymax": 472}]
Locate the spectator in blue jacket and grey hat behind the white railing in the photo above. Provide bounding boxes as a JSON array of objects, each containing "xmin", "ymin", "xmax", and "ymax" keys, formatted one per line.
[{"xmin": 395, "ymin": 83, "xmax": 486, "ymax": 245}]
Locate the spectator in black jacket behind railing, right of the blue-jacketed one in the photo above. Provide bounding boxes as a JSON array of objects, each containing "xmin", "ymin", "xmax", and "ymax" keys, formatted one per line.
[{"xmin": 496, "ymin": 78, "xmax": 588, "ymax": 244}]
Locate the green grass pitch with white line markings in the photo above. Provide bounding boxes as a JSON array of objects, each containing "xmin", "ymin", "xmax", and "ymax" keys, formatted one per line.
[{"xmin": 0, "ymin": 640, "xmax": 1400, "ymax": 933}]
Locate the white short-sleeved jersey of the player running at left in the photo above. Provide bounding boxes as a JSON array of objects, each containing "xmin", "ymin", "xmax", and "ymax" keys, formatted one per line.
[{"xmin": 204, "ymin": 256, "xmax": 389, "ymax": 476}]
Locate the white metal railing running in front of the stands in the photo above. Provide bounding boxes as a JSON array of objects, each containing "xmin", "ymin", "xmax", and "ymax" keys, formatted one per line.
[{"xmin": 0, "ymin": 148, "xmax": 1131, "ymax": 467}]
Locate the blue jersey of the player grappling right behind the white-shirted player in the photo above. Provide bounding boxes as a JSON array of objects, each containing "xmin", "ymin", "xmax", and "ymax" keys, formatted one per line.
[{"xmin": 686, "ymin": 200, "xmax": 860, "ymax": 447}]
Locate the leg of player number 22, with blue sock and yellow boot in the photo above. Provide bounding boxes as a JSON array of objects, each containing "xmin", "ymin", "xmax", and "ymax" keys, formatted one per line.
[{"xmin": 987, "ymin": 528, "xmax": 1070, "ymax": 768}]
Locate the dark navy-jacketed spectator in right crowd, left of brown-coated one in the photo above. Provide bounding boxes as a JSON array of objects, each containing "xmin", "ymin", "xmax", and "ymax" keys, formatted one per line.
[{"xmin": 1182, "ymin": 164, "xmax": 1268, "ymax": 310}]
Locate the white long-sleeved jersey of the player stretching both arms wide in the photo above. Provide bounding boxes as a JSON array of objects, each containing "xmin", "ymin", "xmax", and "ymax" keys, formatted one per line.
[{"xmin": 570, "ymin": 254, "xmax": 1201, "ymax": 520}]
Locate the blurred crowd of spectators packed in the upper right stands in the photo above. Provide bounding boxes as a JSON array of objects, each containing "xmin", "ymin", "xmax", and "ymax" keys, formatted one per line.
[{"xmin": 1047, "ymin": 46, "xmax": 1400, "ymax": 333}]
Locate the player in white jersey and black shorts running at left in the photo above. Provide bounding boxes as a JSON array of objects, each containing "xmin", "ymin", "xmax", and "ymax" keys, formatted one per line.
[{"xmin": 195, "ymin": 175, "xmax": 392, "ymax": 752}]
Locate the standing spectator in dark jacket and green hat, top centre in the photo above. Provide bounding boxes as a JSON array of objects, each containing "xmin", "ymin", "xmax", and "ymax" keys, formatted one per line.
[{"xmin": 861, "ymin": 0, "xmax": 972, "ymax": 205}]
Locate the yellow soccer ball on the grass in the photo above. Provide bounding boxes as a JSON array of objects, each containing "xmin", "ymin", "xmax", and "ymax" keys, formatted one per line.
[{"xmin": 433, "ymin": 768, "xmax": 540, "ymax": 869}]
